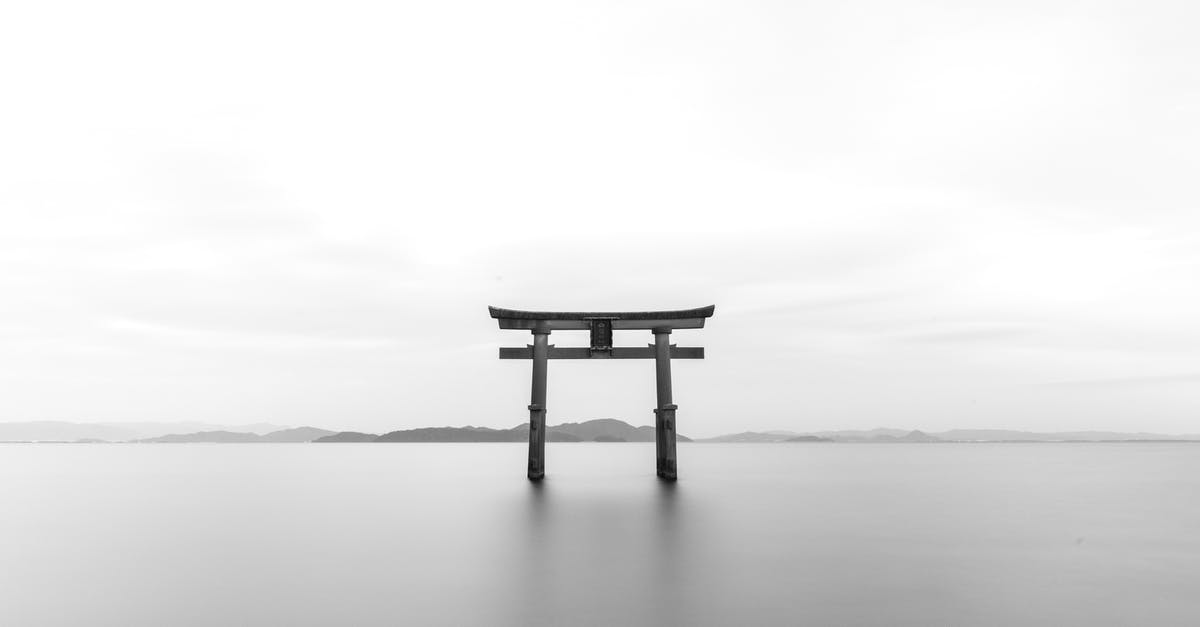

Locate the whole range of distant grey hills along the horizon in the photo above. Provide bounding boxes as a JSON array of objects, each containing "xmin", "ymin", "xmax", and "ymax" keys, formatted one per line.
[{"xmin": 0, "ymin": 418, "xmax": 1200, "ymax": 443}]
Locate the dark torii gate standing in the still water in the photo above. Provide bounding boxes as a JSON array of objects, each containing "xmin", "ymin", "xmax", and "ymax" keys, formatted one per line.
[{"xmin": 487, "ymin": 305, "xmax": 715, "ymax": 480}]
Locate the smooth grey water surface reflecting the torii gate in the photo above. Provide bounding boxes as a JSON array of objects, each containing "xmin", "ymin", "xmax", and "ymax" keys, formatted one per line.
[{"xmin": 0, "ymin": 443, "xmax": 1200, "ymax": 627}]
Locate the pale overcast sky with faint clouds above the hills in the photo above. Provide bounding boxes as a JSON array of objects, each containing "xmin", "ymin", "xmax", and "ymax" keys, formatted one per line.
[{"xmin": 0, "ymin": 0, "xmax": 1200, "ymax": 436}]
